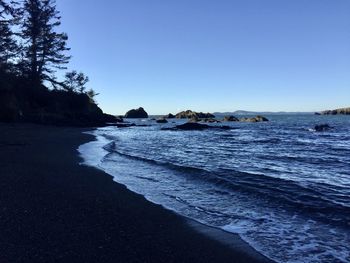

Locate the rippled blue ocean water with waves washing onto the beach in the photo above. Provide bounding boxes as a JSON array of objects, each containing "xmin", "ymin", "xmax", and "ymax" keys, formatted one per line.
[{"xmin": 79, "ymin": 115, "xmax": 350, "ymax": 262}]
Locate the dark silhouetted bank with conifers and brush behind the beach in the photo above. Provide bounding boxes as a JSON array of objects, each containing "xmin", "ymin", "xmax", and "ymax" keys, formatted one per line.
[{"xmin": 0, "ymin": 0, "xmax": 105, "ymax": 126}]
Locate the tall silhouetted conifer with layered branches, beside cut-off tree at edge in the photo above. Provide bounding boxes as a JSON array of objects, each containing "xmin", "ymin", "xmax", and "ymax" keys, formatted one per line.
[{"xmin": 21, "ymin": 0, "xmax": 70, "ymax": 84}]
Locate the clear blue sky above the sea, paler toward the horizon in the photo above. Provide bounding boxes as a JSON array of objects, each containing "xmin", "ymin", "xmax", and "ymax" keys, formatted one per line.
[{"xmin": 57, "ymin": 0, "xmax": 350, "ymax": 114}]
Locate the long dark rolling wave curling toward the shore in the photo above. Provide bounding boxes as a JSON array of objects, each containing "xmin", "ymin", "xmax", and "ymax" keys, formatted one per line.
[{"xmin": 104, "ymin": 142, "xmax": 350, "ymax": 227}]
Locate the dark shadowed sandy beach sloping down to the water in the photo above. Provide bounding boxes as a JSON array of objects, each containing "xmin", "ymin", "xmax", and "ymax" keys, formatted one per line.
[{"xmin": 0, "ymin": 124, "xmax": 265, "ymax": 262}]
